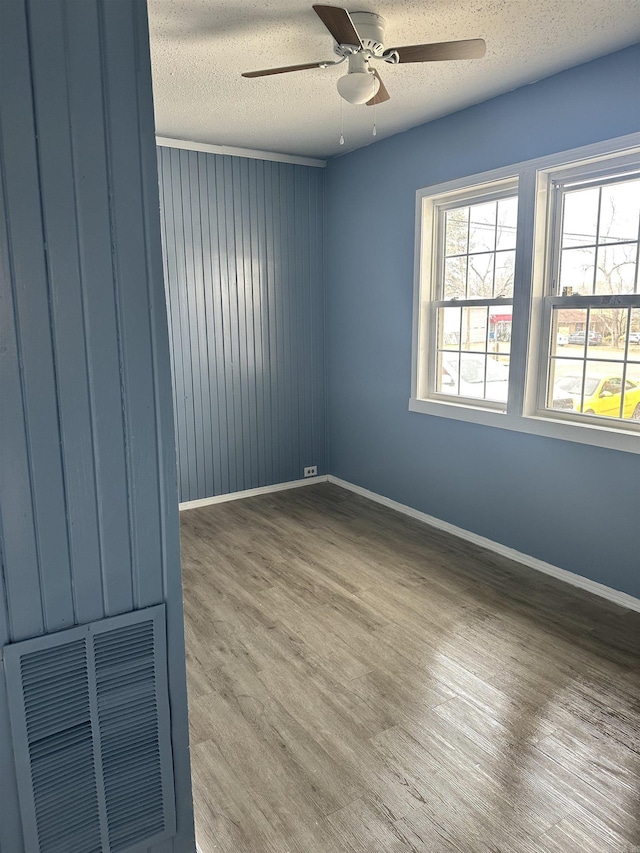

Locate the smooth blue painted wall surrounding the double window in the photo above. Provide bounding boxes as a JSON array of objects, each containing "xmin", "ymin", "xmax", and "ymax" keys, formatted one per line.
[{"xmin": 326, "ymin": 45, "xmax": 640, "ymax": 596}]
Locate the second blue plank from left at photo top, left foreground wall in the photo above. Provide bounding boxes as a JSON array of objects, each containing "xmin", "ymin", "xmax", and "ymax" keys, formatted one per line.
[{"xmin": 29, "ymin": 3, "xmax": 106, "ymax": 622}]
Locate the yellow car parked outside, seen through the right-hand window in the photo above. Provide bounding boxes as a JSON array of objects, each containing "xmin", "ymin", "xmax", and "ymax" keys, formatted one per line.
[{"xmin": 553, "ymin": 375, "xmax": 640, "ymax": 421}]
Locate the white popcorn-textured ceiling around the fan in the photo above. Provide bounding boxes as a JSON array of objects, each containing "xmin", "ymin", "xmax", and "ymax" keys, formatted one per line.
[{"xmin": 148, "ymin": 0, "xmax": 640, "ymax": 158}]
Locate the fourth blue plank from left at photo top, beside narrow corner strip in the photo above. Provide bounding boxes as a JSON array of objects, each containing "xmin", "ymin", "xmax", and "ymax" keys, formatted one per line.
[{"xmin": 104, "ymin": 3, "xmax": 162, "ymax": 615}]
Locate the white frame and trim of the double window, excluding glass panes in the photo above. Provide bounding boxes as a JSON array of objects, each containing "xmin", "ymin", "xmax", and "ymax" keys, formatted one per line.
[{"xmin": 409, "ymin": 128, "xmax": 640, "ymax": 453}]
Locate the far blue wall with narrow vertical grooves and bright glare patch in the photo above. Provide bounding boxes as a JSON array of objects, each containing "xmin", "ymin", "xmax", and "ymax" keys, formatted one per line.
[{"xmin": 158, "ymin": 148, "xmax": 325, "ymax": 501}]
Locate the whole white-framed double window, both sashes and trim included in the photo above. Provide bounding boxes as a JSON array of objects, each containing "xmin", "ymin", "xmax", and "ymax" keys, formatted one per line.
[{"xmin": 409, "ymin": 134, "xmax": 640, "ymax": 453}]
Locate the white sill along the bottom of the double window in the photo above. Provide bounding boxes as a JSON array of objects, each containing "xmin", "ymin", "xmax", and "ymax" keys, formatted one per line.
[{"xmin": 409, "ymin": 397, "xmax": 640, "ymax": 454}]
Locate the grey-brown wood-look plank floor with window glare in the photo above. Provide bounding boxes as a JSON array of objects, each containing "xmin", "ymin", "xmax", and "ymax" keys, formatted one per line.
[{"xmin": 182, "ymin": 484, "xmax": 640, "ymax": 853}]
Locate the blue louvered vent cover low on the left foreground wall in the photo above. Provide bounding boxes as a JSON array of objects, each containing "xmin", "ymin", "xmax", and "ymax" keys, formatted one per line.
[{"xmin": 3, "ymin": 604, "xmax": 175, "ymax": 853}]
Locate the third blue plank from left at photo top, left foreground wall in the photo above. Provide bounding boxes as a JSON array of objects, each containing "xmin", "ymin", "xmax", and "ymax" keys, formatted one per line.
[{"xmin": 66, "ymin": 3, "xmax": 132, "ymax": 614}]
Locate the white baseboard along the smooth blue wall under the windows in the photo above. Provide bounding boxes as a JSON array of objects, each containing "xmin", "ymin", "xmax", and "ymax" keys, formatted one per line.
[{"xmin": 326, "ymin": 474, "xmax": 640, "ymax": 612}]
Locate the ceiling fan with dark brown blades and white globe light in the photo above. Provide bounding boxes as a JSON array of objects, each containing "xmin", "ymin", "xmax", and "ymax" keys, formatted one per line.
[{"xmin": 242, "ymin": 4, "xmax": 486, "ymax": 106}]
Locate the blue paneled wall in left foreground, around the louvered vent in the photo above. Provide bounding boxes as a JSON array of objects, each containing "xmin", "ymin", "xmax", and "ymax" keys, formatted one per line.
[{"xmin": 0, "ymin": 0, "xmax": 195, "ymax": 853}]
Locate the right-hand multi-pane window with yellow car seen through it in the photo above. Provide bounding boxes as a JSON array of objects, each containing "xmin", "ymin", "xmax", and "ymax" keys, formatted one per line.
[{"xmin": 541, "ymin": 169, "xmax": 640, "ymax": 425}]
